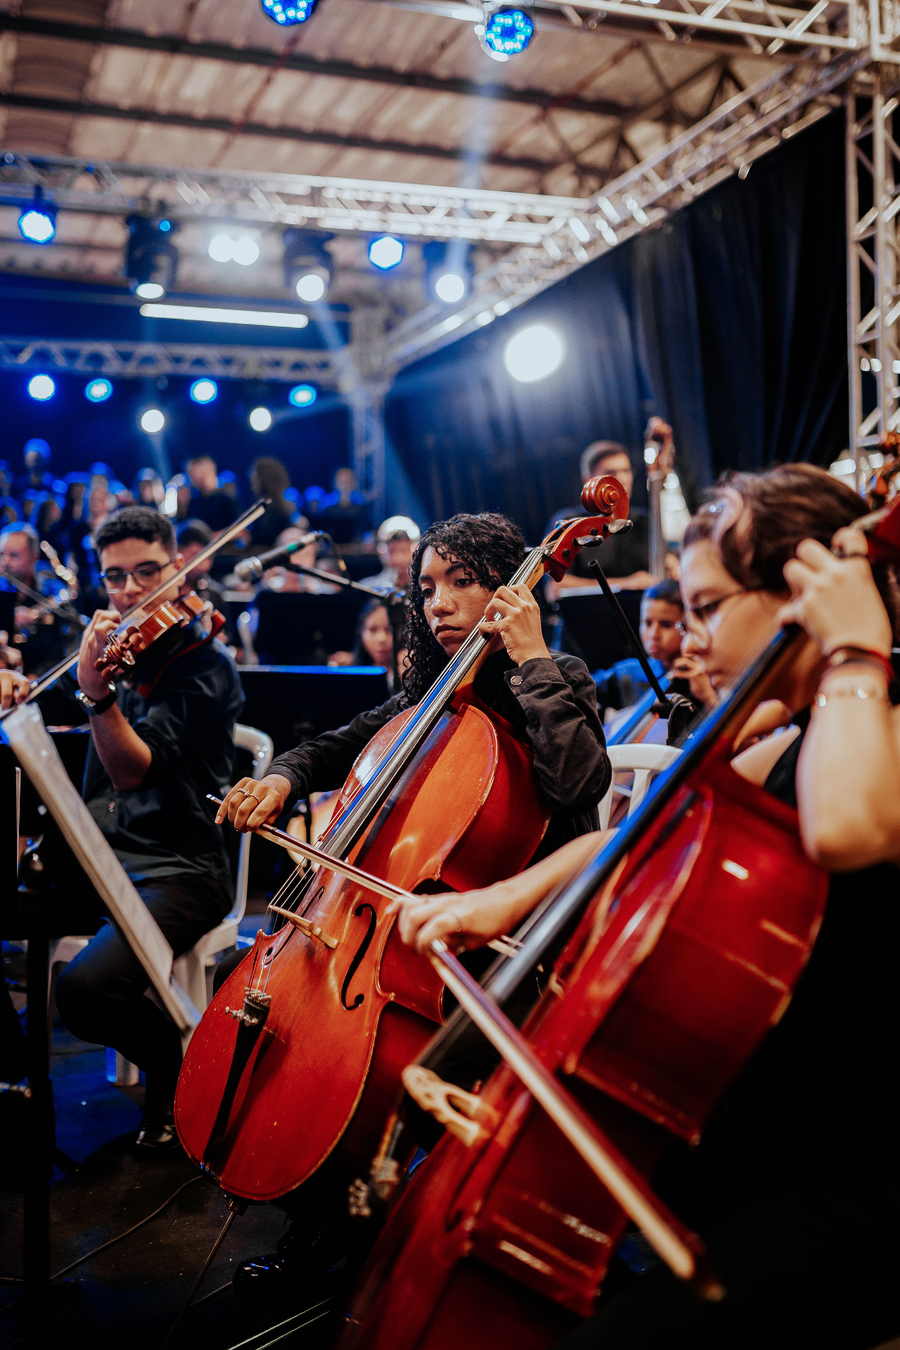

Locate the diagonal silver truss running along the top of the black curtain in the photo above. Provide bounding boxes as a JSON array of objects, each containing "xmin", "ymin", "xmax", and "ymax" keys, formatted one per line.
[{"xmin": 383, "ymin": 53, "xmax": 870, "ymax": 369}]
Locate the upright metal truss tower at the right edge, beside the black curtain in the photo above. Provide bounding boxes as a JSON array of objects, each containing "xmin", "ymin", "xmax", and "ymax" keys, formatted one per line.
[{"xmin": 846, "ymin": 66, "xmax": 900, "ymax": 477}]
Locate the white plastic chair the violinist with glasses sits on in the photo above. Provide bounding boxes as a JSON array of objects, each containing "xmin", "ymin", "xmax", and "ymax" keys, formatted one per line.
[{"xmin": 50, "ymin": 722, "xmax": 275, "ymax": 1087}]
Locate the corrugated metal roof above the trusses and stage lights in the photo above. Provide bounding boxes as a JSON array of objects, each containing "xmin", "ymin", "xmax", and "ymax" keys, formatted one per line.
[{"xmin": 0, "ymin": 0, "xmax": 777, "ymax": 309}]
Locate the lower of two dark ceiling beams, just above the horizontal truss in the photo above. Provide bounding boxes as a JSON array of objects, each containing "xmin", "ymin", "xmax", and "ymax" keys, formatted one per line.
[{"xmin": 0, "ymin": 93, "xmax": 566, "ymax": 174}]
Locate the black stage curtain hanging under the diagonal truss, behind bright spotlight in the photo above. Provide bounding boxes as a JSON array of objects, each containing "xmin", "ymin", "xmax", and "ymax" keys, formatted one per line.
[{"xmin": 386, "ymin": 112, "xmax": 847, "ymax": 541}]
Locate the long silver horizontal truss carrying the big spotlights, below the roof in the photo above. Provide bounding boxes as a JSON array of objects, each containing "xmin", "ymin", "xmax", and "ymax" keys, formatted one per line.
[{"xmin": 0, "ymin": 151, "xmax": 612, "ymax": 247}]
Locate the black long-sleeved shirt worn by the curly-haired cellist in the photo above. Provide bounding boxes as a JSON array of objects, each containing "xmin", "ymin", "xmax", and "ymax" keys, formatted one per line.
[{"xmin": 269, "ymin": 652, "xmax": 613, "ymax": 857}]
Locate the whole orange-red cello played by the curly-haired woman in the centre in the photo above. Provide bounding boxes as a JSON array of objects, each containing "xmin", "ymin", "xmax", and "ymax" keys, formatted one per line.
[{"xmin": 175, "ymin": 478, "xmax": 627, "ymax": 1200}]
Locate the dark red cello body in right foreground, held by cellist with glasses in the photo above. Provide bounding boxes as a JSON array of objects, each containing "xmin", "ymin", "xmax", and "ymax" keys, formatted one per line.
[{"xmin": 340, "ymin": 639, "xmax": 827, "ymax": 1350}]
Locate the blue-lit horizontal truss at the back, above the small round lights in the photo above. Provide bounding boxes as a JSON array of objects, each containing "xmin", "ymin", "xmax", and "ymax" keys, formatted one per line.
[{"xmin": 0, "ymin": 338, "xmax": 339, "ymax": 387}]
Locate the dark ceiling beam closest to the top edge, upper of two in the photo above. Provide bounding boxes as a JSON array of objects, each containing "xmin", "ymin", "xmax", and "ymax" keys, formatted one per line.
[{"xmin": 0, "ymin": 14, "xmax": 661, "ymax": 117}]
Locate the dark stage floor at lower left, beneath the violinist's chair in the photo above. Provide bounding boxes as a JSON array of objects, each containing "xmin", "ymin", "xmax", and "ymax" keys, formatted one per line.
[{"xmin": 0, "ymin": 915, "xmax": 342, "ymax": 1350}]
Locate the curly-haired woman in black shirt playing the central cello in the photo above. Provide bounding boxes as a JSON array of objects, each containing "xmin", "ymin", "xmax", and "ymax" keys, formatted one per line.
[{"xmin": 216, "ymin": 514, "xmax": 613, "ymax": 1300}]
